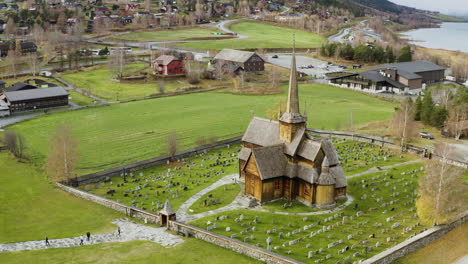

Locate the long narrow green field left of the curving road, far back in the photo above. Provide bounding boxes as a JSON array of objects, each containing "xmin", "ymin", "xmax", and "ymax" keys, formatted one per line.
[{"xmin": 107, "ymin": 27, "xmax": 232, "ymax": 41}]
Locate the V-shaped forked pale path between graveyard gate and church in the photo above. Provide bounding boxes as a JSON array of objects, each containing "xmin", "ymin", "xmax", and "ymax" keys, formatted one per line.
[{"xmin": 177, "ymin": 173, "xmax": 241, "ymax": 223}]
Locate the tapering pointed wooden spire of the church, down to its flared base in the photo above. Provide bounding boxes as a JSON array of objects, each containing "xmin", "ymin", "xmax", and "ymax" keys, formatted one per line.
[{"xmin": 280, "ymin": 36, "xmax": 306, "ymax": 123}]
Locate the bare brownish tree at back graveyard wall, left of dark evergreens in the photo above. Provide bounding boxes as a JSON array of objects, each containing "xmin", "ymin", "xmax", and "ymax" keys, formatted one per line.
[{"xmin": 391, "ymin": 98, "xmax": 417, "ymax": 151}]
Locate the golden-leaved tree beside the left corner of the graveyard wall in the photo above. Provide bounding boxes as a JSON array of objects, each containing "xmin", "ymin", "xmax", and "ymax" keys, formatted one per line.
[{"xmin": 46, "ymin": 124, "xmax": 78, "ymax": 183}]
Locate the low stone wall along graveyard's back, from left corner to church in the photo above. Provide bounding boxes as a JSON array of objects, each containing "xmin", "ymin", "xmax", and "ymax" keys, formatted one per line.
[{"xmin": 71, "ymin": 137, "xmax": 241, "ymax": 186}]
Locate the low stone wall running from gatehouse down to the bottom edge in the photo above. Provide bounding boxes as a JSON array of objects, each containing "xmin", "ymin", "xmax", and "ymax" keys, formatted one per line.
[{"xmin": 168, "ymin": 221, "xmax": 303, "ymax": 264}]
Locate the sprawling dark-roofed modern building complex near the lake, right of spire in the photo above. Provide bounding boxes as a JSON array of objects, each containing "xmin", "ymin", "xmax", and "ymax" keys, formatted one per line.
[{"xmin": 327, "ymin": 61, "xmax": 445, "ymax": 93}]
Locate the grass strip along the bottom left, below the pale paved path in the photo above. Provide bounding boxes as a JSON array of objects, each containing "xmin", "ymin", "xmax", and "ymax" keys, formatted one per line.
[{"xmin": 0, "ymin": 238, "xmax": 260, "ymax": 264}]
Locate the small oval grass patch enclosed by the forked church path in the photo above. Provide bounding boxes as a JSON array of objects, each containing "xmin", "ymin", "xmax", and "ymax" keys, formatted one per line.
[{"xmin": 189, "ymin": 184, "xmax": 241, "ymax": 214}]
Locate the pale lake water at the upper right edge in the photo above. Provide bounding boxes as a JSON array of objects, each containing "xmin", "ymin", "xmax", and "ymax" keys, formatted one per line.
[{"xmin": 403, "ymin": 23, "xmax": 468, "ymax": 52}]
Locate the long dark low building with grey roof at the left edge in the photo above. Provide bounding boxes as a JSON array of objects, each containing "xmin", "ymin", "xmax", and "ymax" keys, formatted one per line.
[{"xmin": 0, "ymin": 87, "xmax": 68, "ymax": 113}]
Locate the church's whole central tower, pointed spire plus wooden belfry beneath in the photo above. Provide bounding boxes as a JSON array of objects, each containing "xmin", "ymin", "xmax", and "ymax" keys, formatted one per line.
[{"xmin": 279, "ymin": 38, "xmax": 307, "ymax": 143}]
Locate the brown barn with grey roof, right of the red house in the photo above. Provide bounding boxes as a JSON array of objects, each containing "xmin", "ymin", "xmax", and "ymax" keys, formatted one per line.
[{"xmin": 213, "ymin": 49, "xmax": 265, "ymax": 72}]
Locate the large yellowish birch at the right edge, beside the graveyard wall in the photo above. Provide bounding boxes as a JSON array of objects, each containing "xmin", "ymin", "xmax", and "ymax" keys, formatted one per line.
[{"xmin": 416, "ymin": 143, "xmax": 467, "ymax": 225}]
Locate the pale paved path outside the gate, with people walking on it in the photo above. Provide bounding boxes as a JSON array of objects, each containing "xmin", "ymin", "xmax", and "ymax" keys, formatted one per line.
[{"xmin": 0, "ymin": 218, "xmax": 184, "ymax": 252}]
